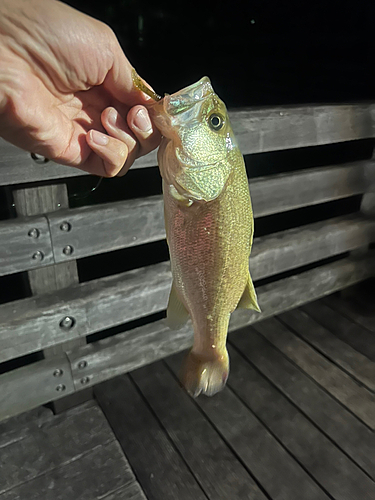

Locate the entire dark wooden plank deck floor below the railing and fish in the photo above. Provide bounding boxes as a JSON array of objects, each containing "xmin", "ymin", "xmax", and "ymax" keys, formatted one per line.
[{"xmin": 0, "ymin": 293, "xmax": 375, "ymax": 500}]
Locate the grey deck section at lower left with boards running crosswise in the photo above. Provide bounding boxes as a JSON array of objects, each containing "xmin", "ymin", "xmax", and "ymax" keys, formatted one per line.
[{"xmin": 0, "ymin": 402, "xmax": 146, "ymax": 500}]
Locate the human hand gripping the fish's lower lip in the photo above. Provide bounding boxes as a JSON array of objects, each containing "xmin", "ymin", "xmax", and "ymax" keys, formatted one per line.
[{"xmin": 0, "ymin": 0, "xmax": 160, "ymax": 177}]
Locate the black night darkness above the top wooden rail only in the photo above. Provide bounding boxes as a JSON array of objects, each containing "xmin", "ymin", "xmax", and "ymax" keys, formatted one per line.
[{"xmin": 67, "ymin": 0, "xmax": 375, "ymax": 107}]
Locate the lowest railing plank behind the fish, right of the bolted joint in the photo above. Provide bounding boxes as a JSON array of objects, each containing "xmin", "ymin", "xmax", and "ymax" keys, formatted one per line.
[{"xmin": 68, "ymin": 254, "xmax": 373, "ymax": 388}]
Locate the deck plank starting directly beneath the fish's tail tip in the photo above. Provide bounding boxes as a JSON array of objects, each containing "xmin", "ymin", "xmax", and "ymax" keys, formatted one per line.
[{"xmin": 166, "ymin": 356, "xmax": 328, "ymax": 500}]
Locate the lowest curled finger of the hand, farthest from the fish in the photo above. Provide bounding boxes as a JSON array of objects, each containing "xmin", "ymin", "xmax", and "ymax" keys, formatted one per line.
[{"xmin": 86, "ymin": 130, "xmax": 128, "ymax": 177}]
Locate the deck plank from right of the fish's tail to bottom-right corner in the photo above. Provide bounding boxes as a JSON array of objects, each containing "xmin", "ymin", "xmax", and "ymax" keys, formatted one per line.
[{"xmin": 228, "ymin": 342, "xmax": 375, "ymax": 500}]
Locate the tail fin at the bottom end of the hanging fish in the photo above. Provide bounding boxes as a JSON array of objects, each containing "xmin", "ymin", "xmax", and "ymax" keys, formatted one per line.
[{"xmin": 182, "ymin": 349, "xmax": 229, "ymax": 398}]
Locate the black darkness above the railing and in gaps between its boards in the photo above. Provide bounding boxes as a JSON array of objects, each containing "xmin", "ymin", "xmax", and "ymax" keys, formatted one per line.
[{"xmin": 0, "ymin": 0, "xmax": 375, "ymax": 310}]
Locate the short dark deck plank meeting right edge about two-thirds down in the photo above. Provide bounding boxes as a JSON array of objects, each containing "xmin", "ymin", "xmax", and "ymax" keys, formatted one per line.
[{"xmin": 302, "ymin": 302, "xmax": 375, "ymax": 361}]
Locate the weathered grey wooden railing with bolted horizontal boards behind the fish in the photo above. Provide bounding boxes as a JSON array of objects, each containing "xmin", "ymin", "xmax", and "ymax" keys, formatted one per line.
[{"xmin": 0, "ymin": 104, "xmax": 375, "ymax": 420}]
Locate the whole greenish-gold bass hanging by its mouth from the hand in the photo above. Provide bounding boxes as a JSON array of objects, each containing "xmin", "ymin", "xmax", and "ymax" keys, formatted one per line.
[{"xmin": 134, "ymin": 71, "xmax": 260, "ymax": 397}]
